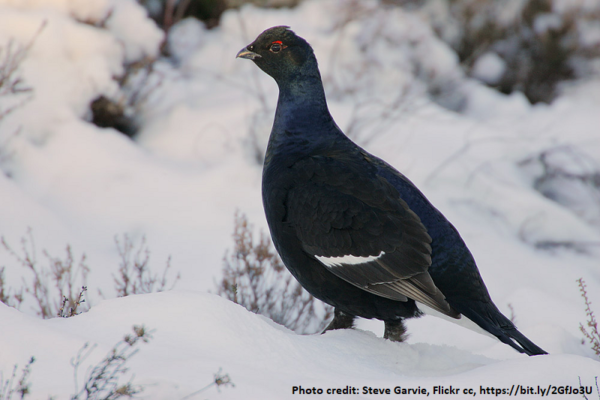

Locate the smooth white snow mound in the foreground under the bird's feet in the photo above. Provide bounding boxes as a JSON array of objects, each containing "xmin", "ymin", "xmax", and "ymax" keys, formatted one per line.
[{"xmin": 0, "ymin": 292, "xmax": 600, "ymax": 400}]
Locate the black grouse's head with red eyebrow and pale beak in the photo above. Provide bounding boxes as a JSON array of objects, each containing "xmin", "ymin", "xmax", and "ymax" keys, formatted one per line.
[{"xmin": 237, "ymin": 26, "xmax": 319, "ymax": 85}]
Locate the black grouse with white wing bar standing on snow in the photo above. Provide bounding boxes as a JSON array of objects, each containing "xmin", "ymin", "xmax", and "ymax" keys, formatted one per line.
[{"xmin": 237, "ymin": 26, "xmax": 546, "ymax": 355}]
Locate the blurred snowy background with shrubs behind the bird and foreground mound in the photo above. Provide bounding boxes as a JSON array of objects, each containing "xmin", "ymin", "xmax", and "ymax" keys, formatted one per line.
[{"xmin": 0, "ymin": 0, "xmax": 600, "ymax": 376}]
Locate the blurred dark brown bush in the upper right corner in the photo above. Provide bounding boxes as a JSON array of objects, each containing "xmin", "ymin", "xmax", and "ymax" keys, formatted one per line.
[{"xmin": 420, "ymin": 0, "xmax": 600, "ymax": 103}]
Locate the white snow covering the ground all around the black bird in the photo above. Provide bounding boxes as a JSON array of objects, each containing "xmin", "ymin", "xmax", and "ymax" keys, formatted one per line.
[{"xmin": 0, "ymin": 0, "xmax": 600, "ymax": 399}]
